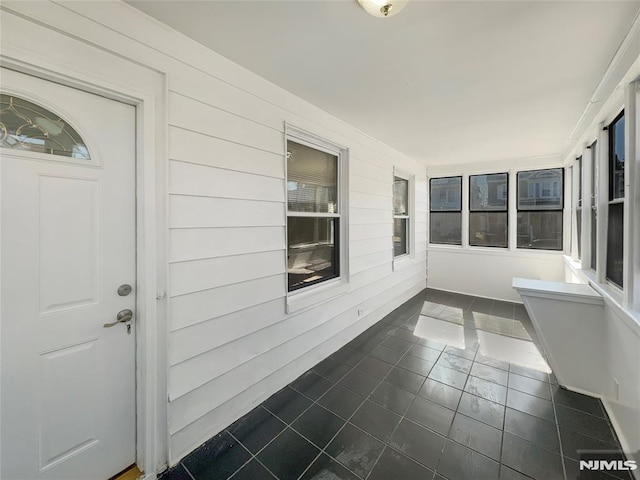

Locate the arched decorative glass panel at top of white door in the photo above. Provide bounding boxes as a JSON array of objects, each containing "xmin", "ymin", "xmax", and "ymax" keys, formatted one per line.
[{"xmin": 0, "ymin": 93, "xmax": 91, "ymax": 160}]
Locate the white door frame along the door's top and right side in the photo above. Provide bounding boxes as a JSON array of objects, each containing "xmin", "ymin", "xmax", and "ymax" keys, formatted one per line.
[{"xmin": 0, "ymin": 45, "xmax": 168, "ymax": 480}]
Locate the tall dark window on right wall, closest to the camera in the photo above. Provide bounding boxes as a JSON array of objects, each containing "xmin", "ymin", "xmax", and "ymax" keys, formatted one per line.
[{"xmin": 606, "ymin": 112, "xmax": 625, "ymax": 288}]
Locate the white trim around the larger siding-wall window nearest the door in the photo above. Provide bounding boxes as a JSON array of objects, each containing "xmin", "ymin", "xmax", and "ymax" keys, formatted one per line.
[{"xmin": 283, "ymin": 122, "xmax": 349, "ymax": 313}]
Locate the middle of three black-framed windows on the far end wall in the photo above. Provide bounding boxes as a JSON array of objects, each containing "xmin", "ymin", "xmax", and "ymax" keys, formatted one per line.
[{"xmin": 469, "ymin": 173, "xmax": 509, "ymax": 248}]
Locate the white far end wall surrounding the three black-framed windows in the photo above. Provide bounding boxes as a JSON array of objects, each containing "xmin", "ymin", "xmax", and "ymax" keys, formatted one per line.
[{"xmin": 427, "ymin": 156, "xmax": 570, "ymax": 302}]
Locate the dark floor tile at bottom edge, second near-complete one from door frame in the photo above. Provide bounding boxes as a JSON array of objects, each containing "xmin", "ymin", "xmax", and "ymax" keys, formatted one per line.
[{"xmin": 258, "ymin": 428, "xmax": 320, "ymax": 480}]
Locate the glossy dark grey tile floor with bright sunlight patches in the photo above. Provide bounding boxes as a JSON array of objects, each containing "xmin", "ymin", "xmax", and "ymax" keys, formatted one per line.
[{"xmin": 161, "ymin": 289, "xmax": 631, "ymax": 480}]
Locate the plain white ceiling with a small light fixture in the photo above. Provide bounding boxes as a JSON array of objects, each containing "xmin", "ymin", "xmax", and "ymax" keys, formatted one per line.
[{"xmin": 129, "ymin": 0, "xmax": 640, "ymax": 164}]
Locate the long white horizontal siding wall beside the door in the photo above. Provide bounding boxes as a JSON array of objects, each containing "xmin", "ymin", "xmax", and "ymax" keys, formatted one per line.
[{"xmin": 3, "ymin": 1, "xmax": 426, "ymax": 464}]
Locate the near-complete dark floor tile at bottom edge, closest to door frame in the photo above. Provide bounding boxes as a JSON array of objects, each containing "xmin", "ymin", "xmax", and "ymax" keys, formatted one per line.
[{"xmin": 182, "ymin": 432, "xmax": 251, "ymax": 480}]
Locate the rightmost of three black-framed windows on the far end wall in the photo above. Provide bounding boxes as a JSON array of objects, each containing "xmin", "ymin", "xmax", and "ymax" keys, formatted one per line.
[{"xmin": 517, "ymin": 168, "xmax": 564, "ymax": 250}]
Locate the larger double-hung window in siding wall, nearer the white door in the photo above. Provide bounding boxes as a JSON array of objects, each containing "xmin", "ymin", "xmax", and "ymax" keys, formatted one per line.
[{"xmin": 287, "ymin": 140, "xmax": 340, "ymax": 291}]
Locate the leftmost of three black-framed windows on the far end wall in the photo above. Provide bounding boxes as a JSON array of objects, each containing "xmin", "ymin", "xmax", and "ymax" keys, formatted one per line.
[{"xmin": 429, "ymin": 177, "xmax": 462, "ymax": 245}]
